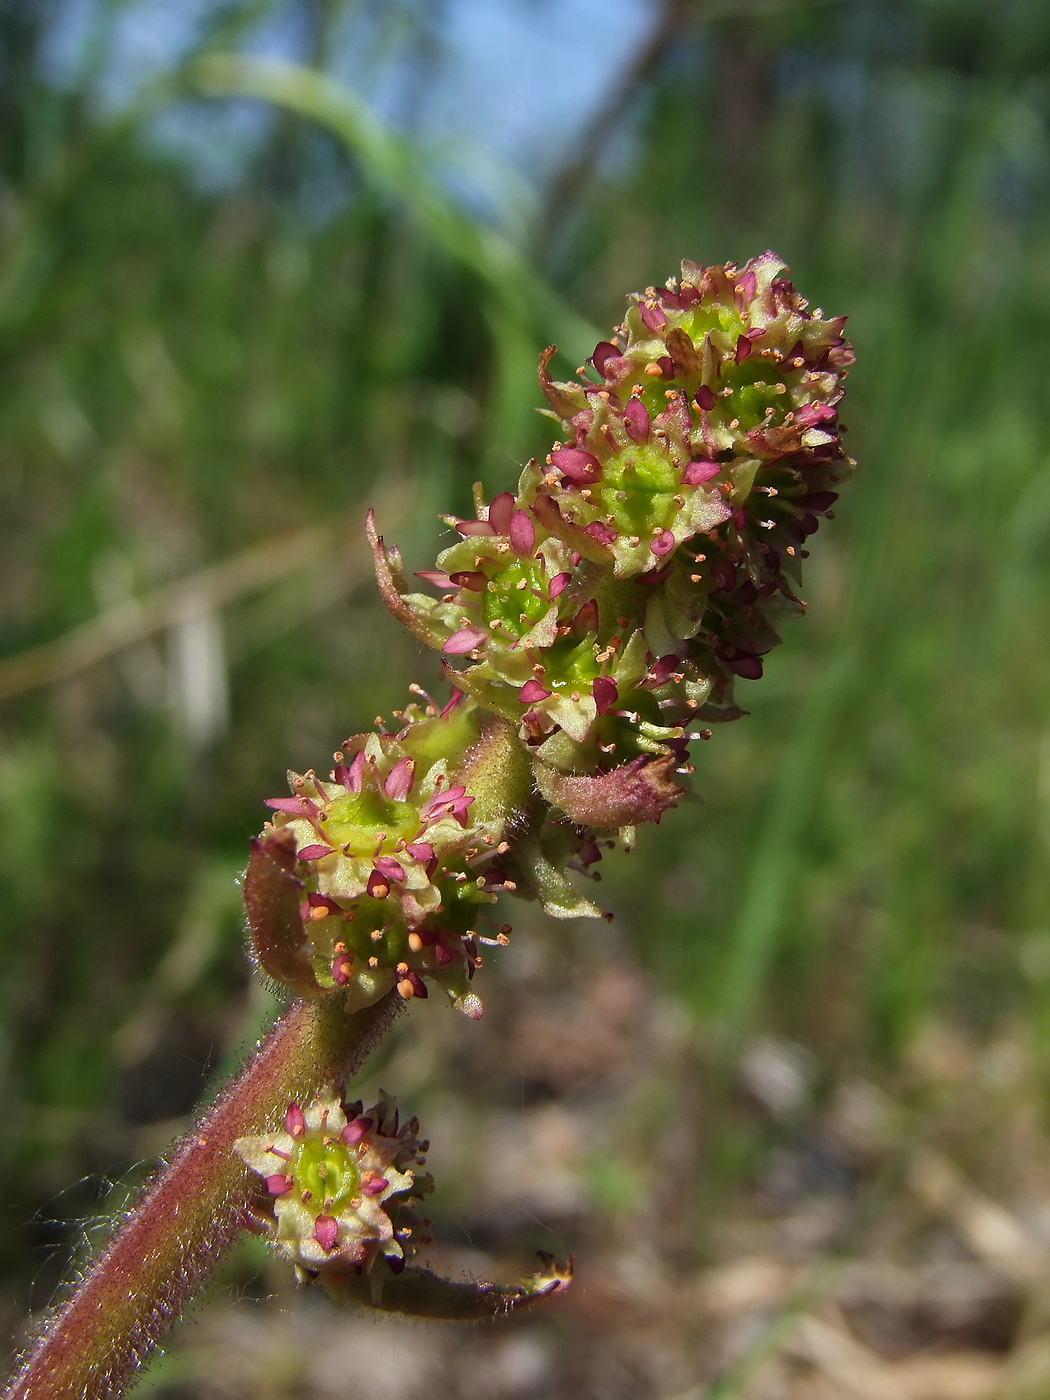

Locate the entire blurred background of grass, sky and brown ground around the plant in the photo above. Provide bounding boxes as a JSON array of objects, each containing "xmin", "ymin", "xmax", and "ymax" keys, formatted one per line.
[{"xmin": 0, "ymin": 0, "xmax": 1050, "ymax": 1400}]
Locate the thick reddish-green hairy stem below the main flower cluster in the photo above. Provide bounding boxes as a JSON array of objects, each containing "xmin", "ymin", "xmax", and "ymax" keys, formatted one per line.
[{"xmin": 3, "ymin": 993, "xmax": 399, "ymax": 1400}]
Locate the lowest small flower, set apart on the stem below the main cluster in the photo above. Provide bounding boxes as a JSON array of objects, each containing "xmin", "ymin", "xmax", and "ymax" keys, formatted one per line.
[{"xmin": 234, "ymin": 1095, "xmax": 433, "ymax": 1278}]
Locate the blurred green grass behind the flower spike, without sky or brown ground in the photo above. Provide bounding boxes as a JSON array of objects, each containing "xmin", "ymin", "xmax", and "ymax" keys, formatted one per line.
[{"xmin": 0, "ymin": 0, "xmax": 1050, "ymax": 1349}]
